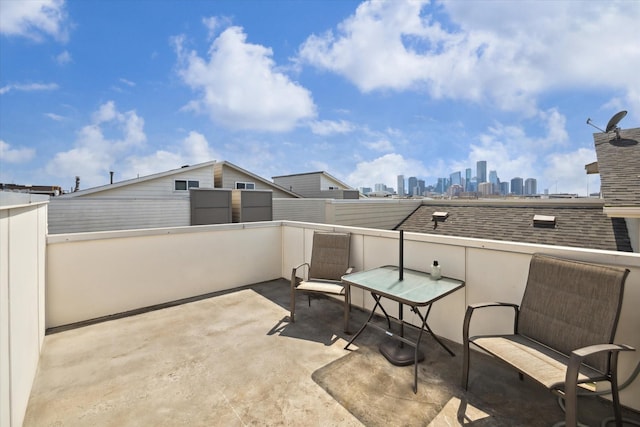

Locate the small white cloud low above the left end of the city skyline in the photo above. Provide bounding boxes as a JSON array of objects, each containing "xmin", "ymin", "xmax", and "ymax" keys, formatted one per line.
[{"xmin": 344, "ymin": 153, "xmax": 429, "ymax": 190}]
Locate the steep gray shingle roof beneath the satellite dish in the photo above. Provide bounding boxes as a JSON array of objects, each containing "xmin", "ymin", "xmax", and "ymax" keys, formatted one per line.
[{"xmin": 593, "ymin": 128, "xmax": 640, "ymax": 207}]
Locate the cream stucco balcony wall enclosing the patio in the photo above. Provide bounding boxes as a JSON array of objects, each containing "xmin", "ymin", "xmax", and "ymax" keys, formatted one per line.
[{"xmin": 5, "ymin": 216, "xmax": 640, "ymax": 425}]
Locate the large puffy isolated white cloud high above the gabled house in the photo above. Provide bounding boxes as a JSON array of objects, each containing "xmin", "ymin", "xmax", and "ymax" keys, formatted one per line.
[{"xmin": 174, "ymin": 27, "xmax": 316, "ymax": 132}]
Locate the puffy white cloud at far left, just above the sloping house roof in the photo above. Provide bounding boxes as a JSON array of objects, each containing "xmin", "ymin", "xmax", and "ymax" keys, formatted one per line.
[{"xmin": 46, "ymin": 101, "xmax": 146, "ymax": 188}]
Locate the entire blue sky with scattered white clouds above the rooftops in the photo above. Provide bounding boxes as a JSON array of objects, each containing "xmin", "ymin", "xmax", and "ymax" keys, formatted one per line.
[{"xmin": 0, "ymin": 0, "xmax": 640, "ymax": 195}]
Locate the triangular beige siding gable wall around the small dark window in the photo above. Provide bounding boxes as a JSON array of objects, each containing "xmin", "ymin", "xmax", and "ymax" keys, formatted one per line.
[{"xmin": 71, "ymin": 165, "xmax": 213, "ymax": 199}]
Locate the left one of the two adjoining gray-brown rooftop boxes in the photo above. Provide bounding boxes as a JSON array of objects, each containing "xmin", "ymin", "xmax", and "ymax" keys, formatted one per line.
[{"xmin": 189, "ymin": 188, "xmax": 232, "ymax": 225}]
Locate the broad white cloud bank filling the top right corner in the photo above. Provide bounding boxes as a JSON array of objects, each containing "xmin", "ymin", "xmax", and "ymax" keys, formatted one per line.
[{"xmin": 298, "ymin": 0, "xmax": 640, "ymax": 115}]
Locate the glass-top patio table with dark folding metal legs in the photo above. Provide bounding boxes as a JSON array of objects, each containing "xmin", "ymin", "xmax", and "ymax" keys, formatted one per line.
[{"xmin": 342, "ymin": 265, "xmax": 464, "ymax": 393}]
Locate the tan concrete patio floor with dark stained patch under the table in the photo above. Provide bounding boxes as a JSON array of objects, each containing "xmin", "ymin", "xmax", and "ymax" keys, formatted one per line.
[{"xmin": 24, "ymin": 280, "xmax": 640, "ymax": 427}]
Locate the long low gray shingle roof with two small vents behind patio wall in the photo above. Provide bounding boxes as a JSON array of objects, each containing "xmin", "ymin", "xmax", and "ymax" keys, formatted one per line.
[{"xmin": 396, "ymin": 199, "xmax": 633, "ymax": 252}]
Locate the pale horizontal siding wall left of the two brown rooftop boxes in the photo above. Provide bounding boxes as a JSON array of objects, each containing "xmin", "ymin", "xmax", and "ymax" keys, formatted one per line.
[{"xmin": 49, "ymin": 200, "xmax": 191, "ymax": 234}]
